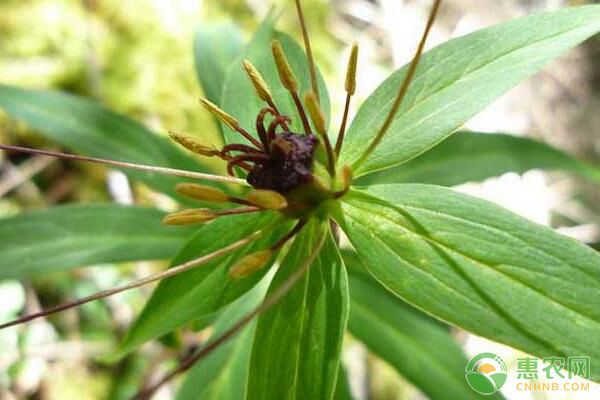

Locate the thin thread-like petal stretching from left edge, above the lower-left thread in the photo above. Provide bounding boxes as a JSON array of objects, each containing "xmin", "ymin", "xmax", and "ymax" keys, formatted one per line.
[{"xmin": 0, "ymin": 144, "xmax": 248, "ymax": 186}]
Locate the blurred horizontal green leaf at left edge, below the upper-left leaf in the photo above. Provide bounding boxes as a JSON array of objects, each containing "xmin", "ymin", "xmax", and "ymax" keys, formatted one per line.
[{"xmin": 0, "ymin": 205, "xmax": 191, "ymax": 279}]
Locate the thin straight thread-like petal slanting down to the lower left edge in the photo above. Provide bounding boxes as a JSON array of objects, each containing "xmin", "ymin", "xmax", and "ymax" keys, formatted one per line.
[{"xmin": 0, "ymin": 230, "xmax": 265, "ymax": 330}]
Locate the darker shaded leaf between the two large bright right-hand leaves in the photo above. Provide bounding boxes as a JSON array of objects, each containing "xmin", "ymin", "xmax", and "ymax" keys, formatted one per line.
[{"xmin": 356, "ymin": 132, "xmax": 600, "ymax": 186}]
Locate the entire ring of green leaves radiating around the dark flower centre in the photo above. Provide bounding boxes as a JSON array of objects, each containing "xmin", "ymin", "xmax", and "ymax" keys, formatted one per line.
[{"xmin": 0, "ymin": 1, "xmax": 600, "ymax": 399}]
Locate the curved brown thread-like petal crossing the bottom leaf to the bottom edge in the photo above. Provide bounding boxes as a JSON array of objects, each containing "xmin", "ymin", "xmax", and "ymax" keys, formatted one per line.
[{"xmin": 135, "ymin": 227, "xmax": 326, "ymax": 400}]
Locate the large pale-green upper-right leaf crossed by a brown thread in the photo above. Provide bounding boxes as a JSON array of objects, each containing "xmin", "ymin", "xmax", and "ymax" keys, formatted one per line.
[{"xmin": 340, "ymin": 6, "xmax": 600, "ymax": 177}]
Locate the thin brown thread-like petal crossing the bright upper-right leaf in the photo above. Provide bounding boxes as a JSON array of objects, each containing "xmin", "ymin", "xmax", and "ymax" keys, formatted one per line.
[{"xmin": 352, "ymin": 0, "xmax": 442, "ymax": 169}]
